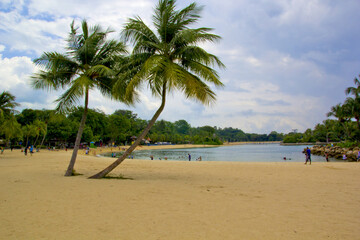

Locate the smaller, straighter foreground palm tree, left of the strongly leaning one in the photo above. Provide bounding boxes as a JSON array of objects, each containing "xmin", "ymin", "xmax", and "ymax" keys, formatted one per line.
[{"xmin": 33, "ymin": 20, "xmax": 126, "ymax": 176}]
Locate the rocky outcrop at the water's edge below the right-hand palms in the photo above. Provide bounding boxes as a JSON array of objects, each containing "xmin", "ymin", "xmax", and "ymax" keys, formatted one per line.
[{"xmin": 311, "ymin": 145, "xmax": 360, "ymax": 161}]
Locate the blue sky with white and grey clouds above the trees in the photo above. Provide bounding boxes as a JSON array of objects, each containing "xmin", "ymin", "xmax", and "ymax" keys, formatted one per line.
[{"xmin": 0, "ymin": 0, "xmax": 360, "ymax": 133}]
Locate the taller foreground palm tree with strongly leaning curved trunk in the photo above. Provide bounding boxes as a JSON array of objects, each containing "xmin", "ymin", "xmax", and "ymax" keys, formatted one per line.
[{"xmin": 90, "ymin": 0, "xmax": 224, "ymax": 178}]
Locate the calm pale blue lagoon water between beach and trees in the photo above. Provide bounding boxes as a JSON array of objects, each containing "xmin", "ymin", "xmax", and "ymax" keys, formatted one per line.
[{"xmin": 103, "ymin": 144, "xmax": 339, "ymax": 162}]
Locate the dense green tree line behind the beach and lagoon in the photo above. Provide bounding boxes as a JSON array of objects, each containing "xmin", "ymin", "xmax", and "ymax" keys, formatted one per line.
[{"xmin": 0, "ymin": 107, "xmax": 283, "ymax": 147}]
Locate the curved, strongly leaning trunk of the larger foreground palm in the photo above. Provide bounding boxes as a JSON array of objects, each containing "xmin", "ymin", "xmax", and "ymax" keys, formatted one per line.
[{"xmin": 89, "ymin": 82, "xmax": 166, "ymax": 179}]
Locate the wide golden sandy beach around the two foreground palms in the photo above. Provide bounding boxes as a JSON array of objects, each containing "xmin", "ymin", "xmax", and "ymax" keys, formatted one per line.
[{"xmin": 0, "ymin": 150, "xmax": 360, "ymax": 240}]
